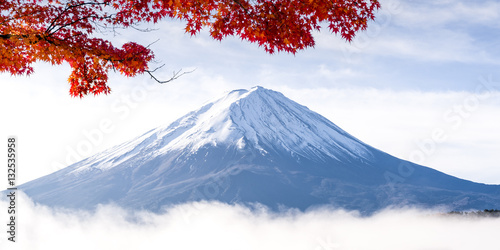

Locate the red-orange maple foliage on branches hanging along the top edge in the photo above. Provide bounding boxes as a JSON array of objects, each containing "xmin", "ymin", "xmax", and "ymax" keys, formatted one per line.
[{"xmin": 0, "ymin": 0, "xmax": 380, "ymax": 97}]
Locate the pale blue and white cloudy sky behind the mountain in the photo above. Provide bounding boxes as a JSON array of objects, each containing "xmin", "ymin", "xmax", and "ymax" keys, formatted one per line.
[{"xmin": 0, "ymin": 1, "xmax": 500, "ymax": 186}]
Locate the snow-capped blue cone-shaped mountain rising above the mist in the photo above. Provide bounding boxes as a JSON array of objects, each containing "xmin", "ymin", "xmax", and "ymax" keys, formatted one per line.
[{"xmin": 19, "ymin": 87, "xmax": 500, "ymax": 214}]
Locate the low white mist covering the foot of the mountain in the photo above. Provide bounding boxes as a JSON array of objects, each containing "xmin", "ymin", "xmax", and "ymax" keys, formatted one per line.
[{"xmin": 0, "ymin": 194, "xmax": 500, "ymax": 250}]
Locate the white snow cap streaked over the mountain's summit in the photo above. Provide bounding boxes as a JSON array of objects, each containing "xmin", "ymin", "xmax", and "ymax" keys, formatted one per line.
[{"xmin": 153, "ymin": 86, "xmax": 376, "ymax": 161}]
